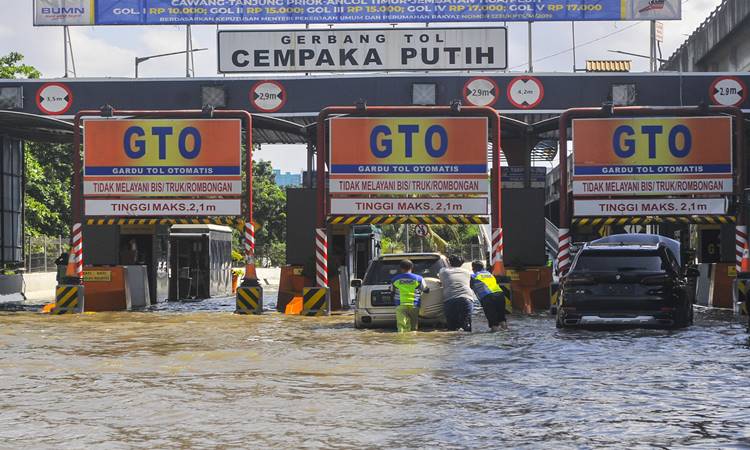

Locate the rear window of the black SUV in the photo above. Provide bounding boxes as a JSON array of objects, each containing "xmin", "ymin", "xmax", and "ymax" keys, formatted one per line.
[{"xmin": 573, "ymin": 250, "xmax": 665, "ymax": 272}]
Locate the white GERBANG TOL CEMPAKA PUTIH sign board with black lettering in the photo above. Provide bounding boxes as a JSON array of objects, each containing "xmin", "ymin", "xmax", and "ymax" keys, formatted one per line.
[{"xmin": 218, "ymin": 28, "xmax": 508, "ymax": 73}]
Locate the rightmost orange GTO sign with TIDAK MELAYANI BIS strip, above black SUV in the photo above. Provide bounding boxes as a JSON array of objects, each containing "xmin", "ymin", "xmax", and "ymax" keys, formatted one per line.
[{"xmin": 573, "ymin": 117, "xmax": 733, "ymax": 197}]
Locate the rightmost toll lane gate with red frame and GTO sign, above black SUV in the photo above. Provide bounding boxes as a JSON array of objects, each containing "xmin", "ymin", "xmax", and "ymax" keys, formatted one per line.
[{"xmin": 558, "ymin": 106, "xmax": 747, "ymax": 308}]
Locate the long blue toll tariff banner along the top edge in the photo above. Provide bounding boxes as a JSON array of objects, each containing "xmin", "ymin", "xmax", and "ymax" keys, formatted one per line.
[{"xmin": 34, "ymin": 0, "xmax": 682, "ymax": 26}]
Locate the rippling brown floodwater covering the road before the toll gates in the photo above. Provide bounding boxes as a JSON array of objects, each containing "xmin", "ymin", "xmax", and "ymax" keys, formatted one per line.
[{"xmin": 0, "ymin": 300, "xmax": 750, "ymax": 449}]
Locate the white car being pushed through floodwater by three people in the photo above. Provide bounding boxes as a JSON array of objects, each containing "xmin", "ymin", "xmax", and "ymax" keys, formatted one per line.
[{"xmin": 352, "ymin": 253, "xmax": 448, "ymax": 328}]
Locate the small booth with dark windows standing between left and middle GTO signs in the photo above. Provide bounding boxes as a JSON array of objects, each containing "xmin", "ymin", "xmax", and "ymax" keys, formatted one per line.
[{"xmin": 168, "ymin": 224, "xmax": 232, "ymax": 301}]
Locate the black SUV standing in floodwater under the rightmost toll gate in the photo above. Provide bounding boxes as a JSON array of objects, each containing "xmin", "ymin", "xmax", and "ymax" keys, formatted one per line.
[{"xmin": 557, "ymin": 235, "xmax": 698, "ymax": 328}]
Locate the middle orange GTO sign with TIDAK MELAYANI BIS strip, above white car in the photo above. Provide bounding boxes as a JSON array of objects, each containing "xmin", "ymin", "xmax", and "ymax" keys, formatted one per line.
[{"xmin": 329, "ymin": 117, "xmax": 488, "ymax": 196}]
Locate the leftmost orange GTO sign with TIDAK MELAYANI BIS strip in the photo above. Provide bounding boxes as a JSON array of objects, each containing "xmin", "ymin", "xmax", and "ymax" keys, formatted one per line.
[{"xmin": 83, "ymin": 119, "xmax": 242, "ymax": 202}]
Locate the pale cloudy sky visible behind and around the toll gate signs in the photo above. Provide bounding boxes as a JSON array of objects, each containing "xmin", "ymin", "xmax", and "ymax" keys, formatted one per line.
[{"xmin": 0, "ymin": 0, "xmax": 728, "ymax": 172}]
